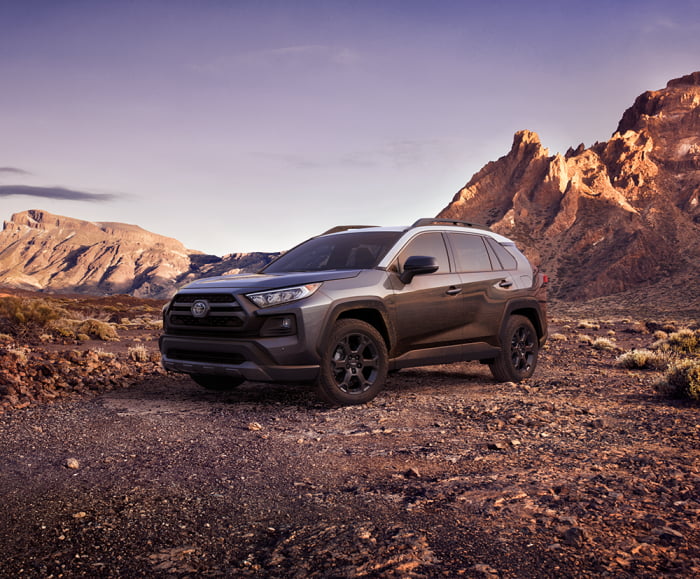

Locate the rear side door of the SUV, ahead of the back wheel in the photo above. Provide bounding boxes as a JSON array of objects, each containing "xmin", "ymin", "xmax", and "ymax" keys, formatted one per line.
[{"xmin": 447, "ymin": 233, "xmax": 514, "ymax": 342}]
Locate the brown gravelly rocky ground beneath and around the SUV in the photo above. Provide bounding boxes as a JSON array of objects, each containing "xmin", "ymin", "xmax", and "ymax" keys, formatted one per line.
[{"xmin": 0, "ymin": 296, "xmax": 700, "ymax": 578}]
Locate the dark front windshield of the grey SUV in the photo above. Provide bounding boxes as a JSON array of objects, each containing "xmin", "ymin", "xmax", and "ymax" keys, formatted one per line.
[{"xmin": 262, "ymin": 231, "xmax": 402, "ymax": 273}]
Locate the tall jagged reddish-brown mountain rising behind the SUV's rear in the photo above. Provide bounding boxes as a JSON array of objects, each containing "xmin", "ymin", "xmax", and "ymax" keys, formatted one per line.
[{"xmin": 438, "ymin": 72, "xmax": 700, "ymax": 300}]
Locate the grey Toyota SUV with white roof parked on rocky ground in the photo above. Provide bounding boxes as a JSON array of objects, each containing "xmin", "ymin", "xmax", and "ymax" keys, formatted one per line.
[{"xmin": 160, "ymin": 219, "xmax": 547, "ymax": 405}]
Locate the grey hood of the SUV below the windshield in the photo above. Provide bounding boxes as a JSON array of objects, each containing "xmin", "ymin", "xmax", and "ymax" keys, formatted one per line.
[{"xmin": 181, "ymin": 269, "xmax": 361, "ymax": 291}]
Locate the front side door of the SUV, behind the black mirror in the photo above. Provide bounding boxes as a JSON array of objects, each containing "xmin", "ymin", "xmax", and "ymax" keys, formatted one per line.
[{"xmin": 389, "ymin": 232, "xmax": 464, "ymax": 354}]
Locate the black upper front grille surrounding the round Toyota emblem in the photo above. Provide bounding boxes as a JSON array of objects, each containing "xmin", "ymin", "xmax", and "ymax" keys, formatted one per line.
[{"xmin": 168, "ymin": 293, "xmax": 246, "ymax": 334}]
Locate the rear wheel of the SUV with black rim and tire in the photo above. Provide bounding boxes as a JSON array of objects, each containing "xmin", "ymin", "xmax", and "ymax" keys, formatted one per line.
[{"xmin": 489, "ymin": 316, "xmax": 540, "ymax": 382}]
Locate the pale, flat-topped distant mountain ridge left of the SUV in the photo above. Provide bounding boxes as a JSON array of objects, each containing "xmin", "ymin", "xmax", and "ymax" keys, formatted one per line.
[{"xmin": 0, "ymin": 209, "xmax": 274, "ymax": 298}]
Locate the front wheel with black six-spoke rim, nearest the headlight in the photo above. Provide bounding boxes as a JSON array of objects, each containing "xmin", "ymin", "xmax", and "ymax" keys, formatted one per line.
[{"xmin": 317, "ymin": 319, "xmax": 389, "ymax": 406}]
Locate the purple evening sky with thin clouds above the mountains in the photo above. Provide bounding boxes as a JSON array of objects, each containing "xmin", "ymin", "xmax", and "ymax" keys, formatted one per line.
[{"xmin": 0, "ymin": 0, "xmax": 700, "ymax": 255}]
